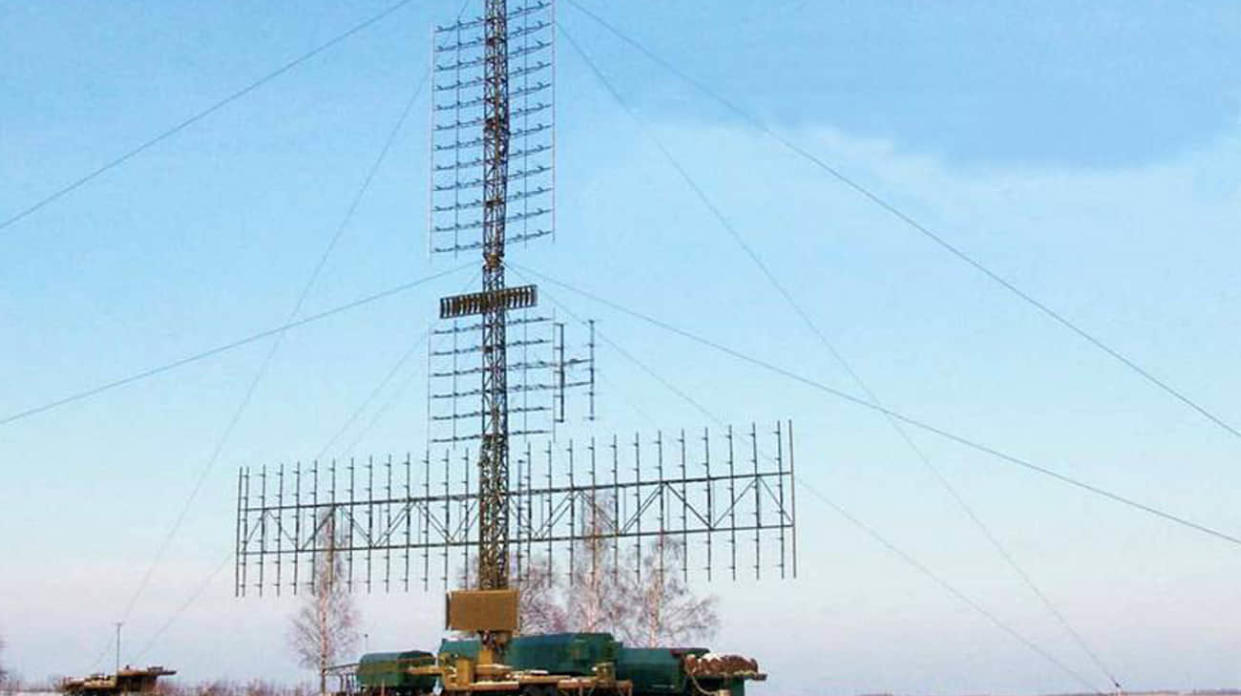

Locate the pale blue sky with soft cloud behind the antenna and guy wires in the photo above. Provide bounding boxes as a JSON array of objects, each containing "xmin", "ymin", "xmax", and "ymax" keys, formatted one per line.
[{"xmin": 0, "ymin": 0, "xmax": 1241, "ymax": 694}]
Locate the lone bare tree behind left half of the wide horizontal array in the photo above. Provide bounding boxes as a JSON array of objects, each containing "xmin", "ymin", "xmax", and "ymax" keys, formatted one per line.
[{"xmin": 289, "ymin": 510, "xmax": 359, "ymax": 696}]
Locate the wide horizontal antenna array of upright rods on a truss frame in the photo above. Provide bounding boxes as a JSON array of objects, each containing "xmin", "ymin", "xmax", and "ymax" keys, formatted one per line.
[{"xmin": 235, "ymin": 423, "xmax": 797, "ymax": 596}]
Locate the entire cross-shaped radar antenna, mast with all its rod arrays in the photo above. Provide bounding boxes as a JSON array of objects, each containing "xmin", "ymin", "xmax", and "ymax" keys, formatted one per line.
[{"xmin": 235, "ymin": 0, "xmax": 797, "ymax": 625}]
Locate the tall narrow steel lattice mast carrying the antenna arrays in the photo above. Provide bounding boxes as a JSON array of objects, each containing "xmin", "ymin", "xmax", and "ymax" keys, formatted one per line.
[{"xmin": 478, "ymin": 0, "xmax": 509, "ymax": 589}]
